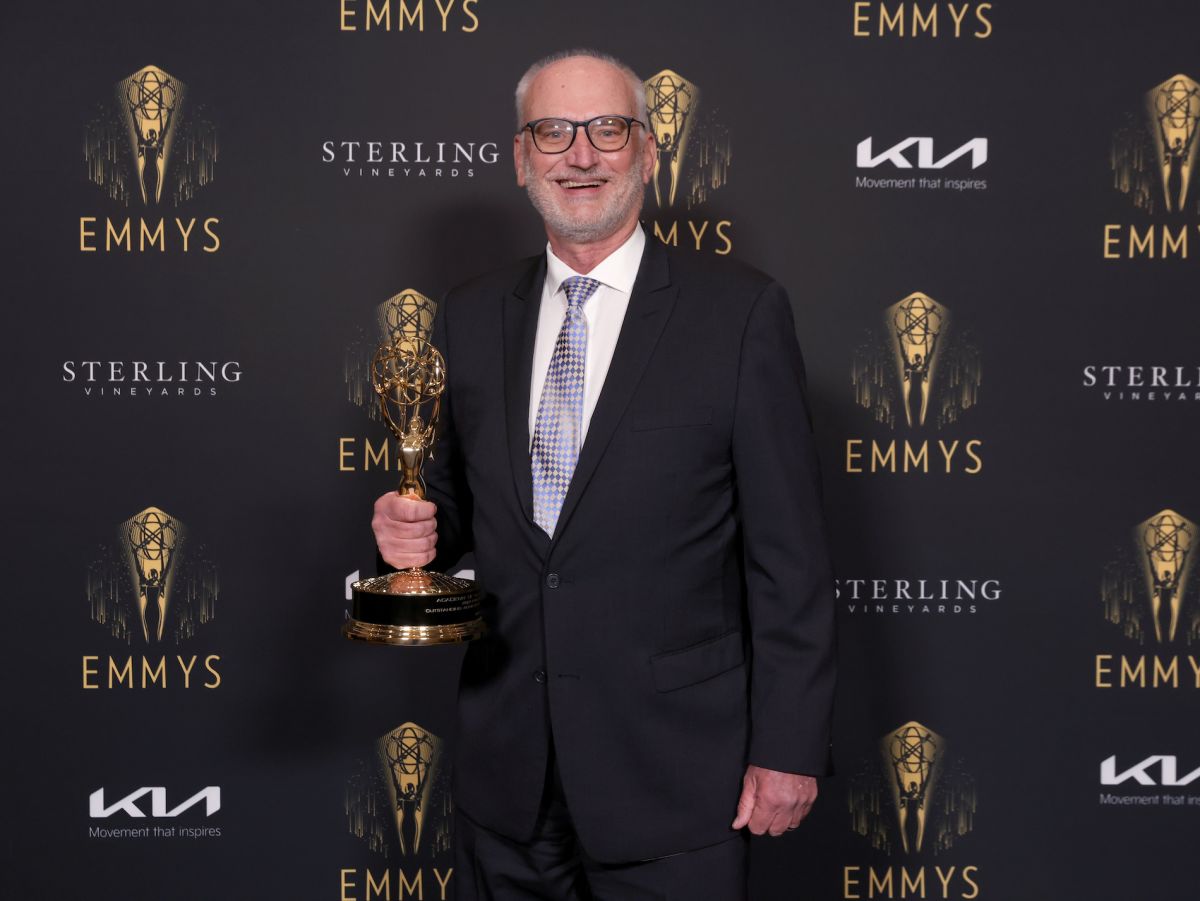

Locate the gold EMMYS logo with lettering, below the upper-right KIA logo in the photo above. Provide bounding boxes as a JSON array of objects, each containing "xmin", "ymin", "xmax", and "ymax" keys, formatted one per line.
[{"xmin": 845, "ymin": 292, "xmax": 983, "ymax": 475}]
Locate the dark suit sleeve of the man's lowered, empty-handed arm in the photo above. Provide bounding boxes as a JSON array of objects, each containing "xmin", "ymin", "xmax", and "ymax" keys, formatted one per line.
[{"xmin": 733, "ymin": 282, "xmax": 835, "ymax": 775}]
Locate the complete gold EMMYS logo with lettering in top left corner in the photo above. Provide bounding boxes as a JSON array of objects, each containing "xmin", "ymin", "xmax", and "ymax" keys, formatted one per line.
[{"xmin": 79, "ymin": 66, "xmax": 221, "ymax": 253}]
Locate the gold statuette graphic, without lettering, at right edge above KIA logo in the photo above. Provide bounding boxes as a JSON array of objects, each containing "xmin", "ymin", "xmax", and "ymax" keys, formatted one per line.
[{"xmin": 1100, "ymin": 510, "xmax": 1200, "ymax": 647}]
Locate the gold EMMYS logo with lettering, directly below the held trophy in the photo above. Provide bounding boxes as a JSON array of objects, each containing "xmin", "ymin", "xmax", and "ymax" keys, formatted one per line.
[{"xmin": 340, "ymin": 722, "xmax": 454, "ymax": 897}]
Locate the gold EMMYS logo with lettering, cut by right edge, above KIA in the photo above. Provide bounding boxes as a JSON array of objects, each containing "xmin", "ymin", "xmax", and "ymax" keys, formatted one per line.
[{"xmin": 1094, "ymin": 510, "xmax": 1200, "ymax": 689}]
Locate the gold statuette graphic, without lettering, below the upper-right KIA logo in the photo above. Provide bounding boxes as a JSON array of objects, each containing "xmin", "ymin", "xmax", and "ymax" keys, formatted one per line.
[{"xmin": 851, "ymin": 292, "xmax": 980, "ymax": 428}]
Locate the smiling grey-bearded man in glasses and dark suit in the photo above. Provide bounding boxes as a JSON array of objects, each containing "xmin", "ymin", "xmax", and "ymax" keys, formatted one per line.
[{"xmin": 372, "ymin": 50, "xmax": 834, "ymax": 901}]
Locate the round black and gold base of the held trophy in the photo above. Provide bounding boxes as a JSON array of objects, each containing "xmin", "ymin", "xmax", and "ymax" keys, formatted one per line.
[{"xmin": 342, "ymin": 569, "xmax": 487, "ymax": 647}]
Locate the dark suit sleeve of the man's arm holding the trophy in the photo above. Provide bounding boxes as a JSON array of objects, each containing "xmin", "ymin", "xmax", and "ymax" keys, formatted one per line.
[{"xmin": 376, "ymin": 295, "xmax": 474, "ymax": 572}]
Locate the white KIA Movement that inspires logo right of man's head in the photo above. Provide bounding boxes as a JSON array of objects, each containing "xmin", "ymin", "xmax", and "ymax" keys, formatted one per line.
[{"xmin": 854, "ymin": 138, "xmax": 988, "ymax": 192}]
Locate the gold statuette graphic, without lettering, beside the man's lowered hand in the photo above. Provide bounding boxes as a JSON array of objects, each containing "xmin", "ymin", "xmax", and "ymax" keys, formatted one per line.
[{"xmin": 850, "ymin": 721, "xmax": 976, "ymax": 855}]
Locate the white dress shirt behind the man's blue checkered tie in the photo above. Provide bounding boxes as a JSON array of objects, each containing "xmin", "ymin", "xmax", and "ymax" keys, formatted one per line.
[{"xmin": 529, "ymin": 226, "xmax": 646, "ymax": 446}]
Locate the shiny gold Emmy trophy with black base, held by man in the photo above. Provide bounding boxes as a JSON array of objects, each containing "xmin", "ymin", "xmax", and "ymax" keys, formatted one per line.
[{"xmin": 342, "ymin": 293, "xmax": 485, "ymax": 645}]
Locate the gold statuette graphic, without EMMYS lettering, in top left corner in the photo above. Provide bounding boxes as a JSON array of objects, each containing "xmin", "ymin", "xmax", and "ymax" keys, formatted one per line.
[{"xmin": 84, "ymin": 66, "xmax": 217, "ymax": 206}]
